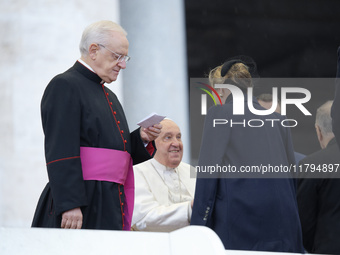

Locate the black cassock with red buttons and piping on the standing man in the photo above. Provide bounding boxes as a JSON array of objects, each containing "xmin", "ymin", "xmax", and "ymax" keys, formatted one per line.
[{"xmin": 32, "ymin": 61, "xmax": 154, "ymax": 230}]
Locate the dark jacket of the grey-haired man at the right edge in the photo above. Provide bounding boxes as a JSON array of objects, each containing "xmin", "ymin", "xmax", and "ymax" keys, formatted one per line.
[{"xmin": 298, "ymin": 139, "xmax": 340, "ymax": 254}]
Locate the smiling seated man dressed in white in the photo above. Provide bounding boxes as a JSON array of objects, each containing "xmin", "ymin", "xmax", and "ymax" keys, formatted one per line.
[{"xmin": 132, "ymin": 119, "xmax": 196, "ymax": 232}]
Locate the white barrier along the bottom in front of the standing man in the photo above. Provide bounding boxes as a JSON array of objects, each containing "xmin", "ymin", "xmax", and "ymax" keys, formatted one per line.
[{"xmin": 0, "ymin": 226, "xmax": 225, "ymax": 255}]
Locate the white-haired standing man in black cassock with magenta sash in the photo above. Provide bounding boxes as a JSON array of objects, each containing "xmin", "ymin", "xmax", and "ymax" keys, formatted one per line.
[{"xmin": 32, "ymin": 21, "xmax": 161, "ymax": 230}]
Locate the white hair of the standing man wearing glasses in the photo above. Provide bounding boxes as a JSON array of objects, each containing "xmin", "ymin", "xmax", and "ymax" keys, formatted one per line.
[{"xmin": 79, "ymin": 20, "xmax": 127, "ymax": 56}]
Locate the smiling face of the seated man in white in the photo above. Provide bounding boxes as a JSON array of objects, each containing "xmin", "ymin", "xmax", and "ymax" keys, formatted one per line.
[{"xmin": 154, "ymin": 120, "xmax": 183, "ymax": 168}]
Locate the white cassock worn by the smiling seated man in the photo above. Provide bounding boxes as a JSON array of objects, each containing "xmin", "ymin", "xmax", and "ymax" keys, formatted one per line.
[{"xmin": 132, "ymin": 158, "xmax": 196, "ymax": 232}]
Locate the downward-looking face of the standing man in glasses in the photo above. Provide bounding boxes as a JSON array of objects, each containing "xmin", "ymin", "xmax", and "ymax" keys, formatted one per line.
[{"xmin": 89, "ymin": 32, "xmax": 129, "ymax": 83}]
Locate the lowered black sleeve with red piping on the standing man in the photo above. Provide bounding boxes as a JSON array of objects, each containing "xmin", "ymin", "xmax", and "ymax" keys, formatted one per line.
[{"xmin": 41, "ymin": 78, "xmax": 87, "ymax": 215}]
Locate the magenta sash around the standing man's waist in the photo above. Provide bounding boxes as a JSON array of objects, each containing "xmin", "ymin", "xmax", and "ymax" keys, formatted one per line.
[{"xmin": 80, "ymin": 147, "xmax": 135, "ymax": 230}]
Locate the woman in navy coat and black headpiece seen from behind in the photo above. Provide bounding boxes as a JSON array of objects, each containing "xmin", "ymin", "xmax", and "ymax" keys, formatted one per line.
[{"xmin": 191, "ymin": 57, "xmax": 304, "ymax": 253}]
